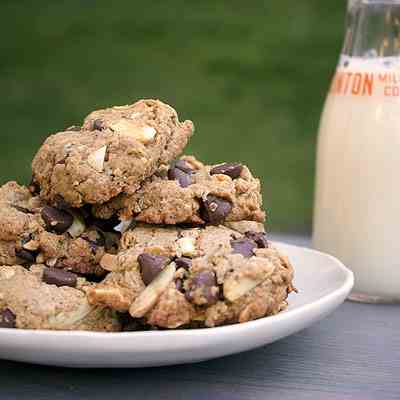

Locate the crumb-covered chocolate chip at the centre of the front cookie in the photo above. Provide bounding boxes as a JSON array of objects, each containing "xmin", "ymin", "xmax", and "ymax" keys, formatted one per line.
[{"xmin": 186, "ymin": 271, "xmax": 219, "ymax": 306}]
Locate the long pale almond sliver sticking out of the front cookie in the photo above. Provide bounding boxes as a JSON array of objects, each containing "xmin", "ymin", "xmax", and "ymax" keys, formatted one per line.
[{"xmin": 129, "ymin": 262, "xmax": 176, "ymax": 318}]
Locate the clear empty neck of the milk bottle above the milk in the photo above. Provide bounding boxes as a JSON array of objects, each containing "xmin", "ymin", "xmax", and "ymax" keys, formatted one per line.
[{"xmin": 342, "ymin": 0, "xmax": 400, "ymax": 58}]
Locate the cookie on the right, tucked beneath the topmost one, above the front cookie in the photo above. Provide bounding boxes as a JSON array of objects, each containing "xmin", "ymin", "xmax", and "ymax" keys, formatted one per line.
[{"xmin": 93, "ymin": 156, "xmax": 265, "ymax": 225}]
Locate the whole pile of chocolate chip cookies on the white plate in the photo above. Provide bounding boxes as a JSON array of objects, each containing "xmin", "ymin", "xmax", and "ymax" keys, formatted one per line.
[{"xmin": 0, "ymin": 100, "xmax": 293, "ymax": 331}]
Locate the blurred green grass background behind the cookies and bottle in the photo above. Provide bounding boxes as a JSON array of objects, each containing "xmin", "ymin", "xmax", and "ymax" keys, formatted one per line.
[{"xmin": 0, "ymin": 0, "xmax": 345, "ymax": 233}]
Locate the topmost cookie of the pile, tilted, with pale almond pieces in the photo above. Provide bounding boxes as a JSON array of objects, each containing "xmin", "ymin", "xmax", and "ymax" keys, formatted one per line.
[{"xmin": 32, "ymin": 100, "xmax": 193, "ymax": 207}]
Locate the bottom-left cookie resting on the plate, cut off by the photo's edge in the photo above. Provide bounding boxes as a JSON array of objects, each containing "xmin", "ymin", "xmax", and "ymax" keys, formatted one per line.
[{"xmin": 0, "ymin": 265, "xmax": 120, "ymax": 332}]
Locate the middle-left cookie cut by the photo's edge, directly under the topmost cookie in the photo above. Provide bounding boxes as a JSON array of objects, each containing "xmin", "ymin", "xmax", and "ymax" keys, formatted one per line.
[{"xmin": 0, "ymin": 182, "xmax": 119, "ymax": 275}]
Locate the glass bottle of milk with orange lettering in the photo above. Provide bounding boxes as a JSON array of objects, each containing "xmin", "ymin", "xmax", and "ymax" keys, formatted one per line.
[{"xmin": 313, "ymin": 0, "xmax": 400, "ymax": 303}]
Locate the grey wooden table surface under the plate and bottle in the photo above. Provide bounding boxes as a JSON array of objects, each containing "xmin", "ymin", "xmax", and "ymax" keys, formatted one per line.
[{"xmin": 0, "ymin": 236, "xmax": 400, "ymax": 400}]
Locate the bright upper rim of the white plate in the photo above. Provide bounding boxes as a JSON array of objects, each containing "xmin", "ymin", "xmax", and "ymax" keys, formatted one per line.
[{"xmin": 0, "ymin": 241, "xmax": 354, "ymax": 340}]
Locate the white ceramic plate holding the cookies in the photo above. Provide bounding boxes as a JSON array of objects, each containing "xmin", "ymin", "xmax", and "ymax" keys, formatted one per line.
[{"xmin": 0, "ymin": 243, "xmax": 353, "ymax": 367}]
